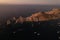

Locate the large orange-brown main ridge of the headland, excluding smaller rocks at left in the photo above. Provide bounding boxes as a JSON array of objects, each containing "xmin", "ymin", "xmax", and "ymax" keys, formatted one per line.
[{"xmin": 24, "ymin": 9, "xmax": 60, "ymax": 21}]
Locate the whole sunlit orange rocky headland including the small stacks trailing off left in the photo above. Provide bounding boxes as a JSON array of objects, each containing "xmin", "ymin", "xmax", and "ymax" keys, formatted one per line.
[{"xmin": 7, "ymin": 8, "xmax": 60, "ymax": 24}]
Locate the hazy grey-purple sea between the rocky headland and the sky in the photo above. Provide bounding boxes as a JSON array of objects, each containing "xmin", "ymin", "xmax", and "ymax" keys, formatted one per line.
[{"xmin": 0, "ymin": 5, "xmax": 60, "ymax": 23}]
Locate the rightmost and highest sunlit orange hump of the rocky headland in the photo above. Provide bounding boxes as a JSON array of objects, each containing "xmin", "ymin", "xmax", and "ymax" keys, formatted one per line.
[{"xmin": 45, "ymin": 9, "xmax": 60, "ymax": 19}]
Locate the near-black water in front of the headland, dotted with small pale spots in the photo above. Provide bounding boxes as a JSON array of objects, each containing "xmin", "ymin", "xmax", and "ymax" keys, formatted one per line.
[{"xmin": 0, "ymin": 20, "xmax": 59, "ymax": 40}]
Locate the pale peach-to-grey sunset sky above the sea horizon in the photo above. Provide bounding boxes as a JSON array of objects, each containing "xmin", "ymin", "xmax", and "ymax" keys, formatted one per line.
[{"xmin": 0, "ymin": 0, "xmax": 60, "ymax": 5}]
